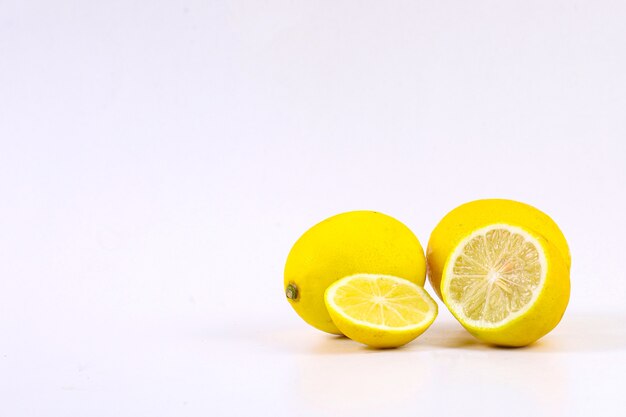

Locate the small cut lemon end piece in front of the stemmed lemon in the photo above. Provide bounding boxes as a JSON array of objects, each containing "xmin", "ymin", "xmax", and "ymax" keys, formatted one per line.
[{"xmin": 325, "ymin": 274, "xmax": 437, "ymax": 348}]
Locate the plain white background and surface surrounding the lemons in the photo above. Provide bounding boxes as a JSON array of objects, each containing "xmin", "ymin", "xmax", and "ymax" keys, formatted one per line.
[{"xmin": 0, "ymin": 0, "xmax": 626, "ymax": 417}]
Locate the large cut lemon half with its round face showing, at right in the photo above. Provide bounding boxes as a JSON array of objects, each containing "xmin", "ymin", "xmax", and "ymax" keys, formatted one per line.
[{"xmin": 441, "ymin": 224, "xmax": 570, "ymax": 346}]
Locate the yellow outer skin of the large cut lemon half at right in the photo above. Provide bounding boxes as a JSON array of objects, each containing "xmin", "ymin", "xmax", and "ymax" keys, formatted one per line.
[{"xmin": 441, "ymin": 225, "xmax": 570, "ymax": 347}]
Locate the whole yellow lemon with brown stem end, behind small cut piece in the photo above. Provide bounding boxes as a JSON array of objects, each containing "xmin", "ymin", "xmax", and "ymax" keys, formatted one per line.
[{"xmin": 284, "ymin": 211, "xmax": 426, "ymax": 334}]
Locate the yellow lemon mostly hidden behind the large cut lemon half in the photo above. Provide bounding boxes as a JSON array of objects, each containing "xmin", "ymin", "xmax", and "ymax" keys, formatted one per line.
[{"xmin": 426, "ymin": 199, "xmax": 571, "ymax": 298}]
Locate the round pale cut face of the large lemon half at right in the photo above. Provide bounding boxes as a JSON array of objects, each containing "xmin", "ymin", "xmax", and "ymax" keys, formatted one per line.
[{"xmin": 444, "ymin": 224, "xmax": 546, "ymax": 327}]
